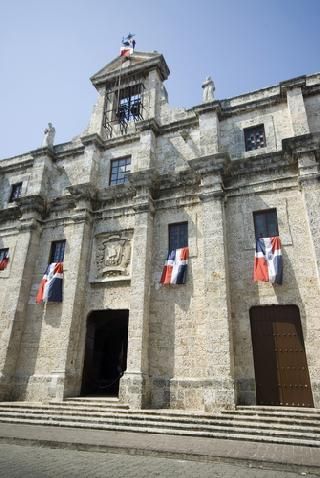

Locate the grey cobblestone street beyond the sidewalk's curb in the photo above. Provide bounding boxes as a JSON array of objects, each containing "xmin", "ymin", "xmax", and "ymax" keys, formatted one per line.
[{"xmin": 0, "ymin": 444, "xmax": 320, "ymax": 478}]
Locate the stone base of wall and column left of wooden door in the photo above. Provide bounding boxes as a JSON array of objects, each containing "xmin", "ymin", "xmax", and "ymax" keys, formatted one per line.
[{"xmin": 151, "ymin": 378, "xmax": 235, "ymax": 412}]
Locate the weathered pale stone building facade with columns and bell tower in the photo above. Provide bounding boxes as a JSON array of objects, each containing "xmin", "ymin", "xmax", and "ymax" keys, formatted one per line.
[{"xmin": 0, "ymin": 52, "xmax": 320, "ymax": 411}]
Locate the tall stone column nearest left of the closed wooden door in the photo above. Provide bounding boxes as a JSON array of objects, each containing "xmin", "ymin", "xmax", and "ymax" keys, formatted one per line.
[{"xmin": 189, "ymin": 155, "xmax": 235, "ymax": 409}]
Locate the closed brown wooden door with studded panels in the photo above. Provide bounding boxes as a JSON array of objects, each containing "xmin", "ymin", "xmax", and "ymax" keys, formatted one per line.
[{"xmin": 250, "ymin": 305, "xmax": 314, "ymax": 407}]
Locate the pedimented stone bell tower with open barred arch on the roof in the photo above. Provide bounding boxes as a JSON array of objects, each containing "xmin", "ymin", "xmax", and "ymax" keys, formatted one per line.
[{"xmin": 88, "ymin": 51, "xmax": 170, "ymax": 140}]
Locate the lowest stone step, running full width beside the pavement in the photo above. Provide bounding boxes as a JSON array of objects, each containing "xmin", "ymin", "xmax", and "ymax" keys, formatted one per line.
[{"xmin": 1, "ymin": 418, "xmax": 320, "ymax": 447}]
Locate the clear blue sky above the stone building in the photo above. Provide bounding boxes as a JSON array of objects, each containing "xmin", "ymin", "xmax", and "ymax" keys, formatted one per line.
[{"xmin": 0, "ymin": 0, "xmax": 320, "ymax": 158}]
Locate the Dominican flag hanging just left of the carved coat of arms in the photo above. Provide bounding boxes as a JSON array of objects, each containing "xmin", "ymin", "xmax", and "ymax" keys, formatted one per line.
[{"xmin": 36, "ymin": 262, "xmax": 63, "ymax": 304}]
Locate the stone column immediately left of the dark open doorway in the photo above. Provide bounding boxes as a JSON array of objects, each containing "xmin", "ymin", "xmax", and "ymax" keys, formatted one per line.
[{"xmin": 49, "ymin": 184, "xmax": 94, "ymax": 400}]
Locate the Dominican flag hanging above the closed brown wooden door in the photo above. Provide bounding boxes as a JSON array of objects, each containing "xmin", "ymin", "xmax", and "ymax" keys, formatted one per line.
[{"xmin": 253, "ymin": 236, "xmax": 283, "ymax": 284}]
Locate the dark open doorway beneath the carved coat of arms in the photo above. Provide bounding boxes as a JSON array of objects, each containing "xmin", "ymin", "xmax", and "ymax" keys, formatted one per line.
[{"xmin": 81, "ymin": 309, "xmax": 129, "ymax": 396}]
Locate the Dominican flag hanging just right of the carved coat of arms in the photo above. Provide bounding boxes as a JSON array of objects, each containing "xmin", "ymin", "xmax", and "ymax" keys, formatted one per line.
[{"xmin": 160, "ymin": 247, "xmax": 189, "ymax": 284}]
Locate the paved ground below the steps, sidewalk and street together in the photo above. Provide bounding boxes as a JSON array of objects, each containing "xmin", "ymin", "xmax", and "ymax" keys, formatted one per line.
[{"xmin": 0, "ymin": 423, "xmax": 320, "ymax": 478}]
